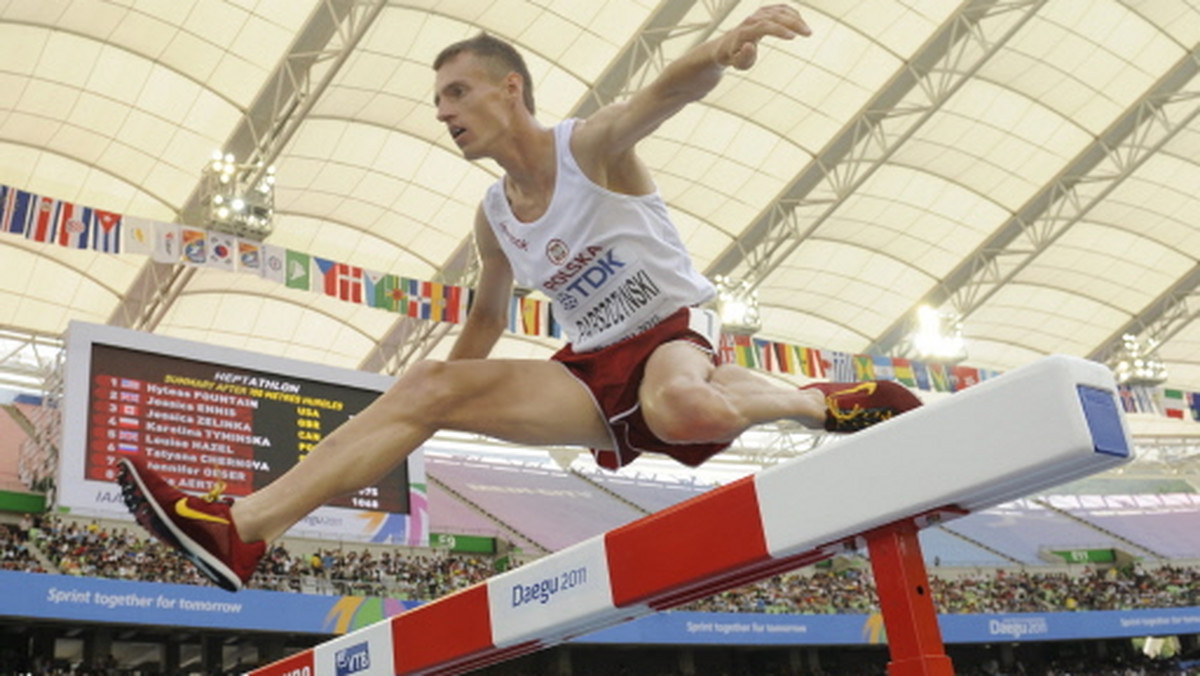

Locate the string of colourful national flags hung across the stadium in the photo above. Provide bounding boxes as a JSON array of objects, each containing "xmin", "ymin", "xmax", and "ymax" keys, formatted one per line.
[{"xmin": 7, "ymin": 185, "xmax": 1200, "ymax": 421}]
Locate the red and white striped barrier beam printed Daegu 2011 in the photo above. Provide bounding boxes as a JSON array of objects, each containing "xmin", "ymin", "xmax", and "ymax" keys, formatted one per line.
[{"xmin": 251, "ymin": 357, "xmax": 1133, "ymax": 676}]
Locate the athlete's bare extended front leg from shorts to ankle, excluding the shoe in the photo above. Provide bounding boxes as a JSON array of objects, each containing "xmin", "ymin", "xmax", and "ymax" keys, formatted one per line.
[{"xmin": 233, "ymin": 359, "xmax": 612, "ymax": 540}]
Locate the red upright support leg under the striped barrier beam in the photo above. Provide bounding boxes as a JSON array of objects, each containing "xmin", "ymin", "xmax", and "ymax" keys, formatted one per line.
[{"xmin": 866, "ymin": 520, "xmax": 954, "ymax": 676}]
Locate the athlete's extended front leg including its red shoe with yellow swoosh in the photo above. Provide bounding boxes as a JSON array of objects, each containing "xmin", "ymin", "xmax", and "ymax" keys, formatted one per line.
[{"xmin": 120, "ymin": 360, "xmax": 612, "ymax": 590}]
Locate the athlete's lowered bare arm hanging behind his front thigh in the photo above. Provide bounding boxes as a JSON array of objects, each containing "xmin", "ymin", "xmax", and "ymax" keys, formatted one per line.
[{"xmin": 449, "ymin": 207, "xmax": 512, "ymax": 360}]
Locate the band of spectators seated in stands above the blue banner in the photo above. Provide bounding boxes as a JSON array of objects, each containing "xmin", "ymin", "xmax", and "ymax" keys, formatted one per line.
[{"xmin": 0, "ymin": 515, "xmax": 1200, "ymax": 614}]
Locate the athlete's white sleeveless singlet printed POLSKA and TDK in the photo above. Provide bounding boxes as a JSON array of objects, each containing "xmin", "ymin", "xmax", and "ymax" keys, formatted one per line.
[{"xmin": 484, "ymin": 119, "xmax": 716, "ymax": 352}]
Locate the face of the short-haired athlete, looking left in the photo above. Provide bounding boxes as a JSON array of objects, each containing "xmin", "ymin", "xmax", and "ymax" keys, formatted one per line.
[{"xmin": 433, "ymin": 52, "xmax": 510, "ymax": 160}]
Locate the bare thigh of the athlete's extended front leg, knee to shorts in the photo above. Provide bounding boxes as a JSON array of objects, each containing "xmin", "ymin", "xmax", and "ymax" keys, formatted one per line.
[{"xmin": 440, "ymin": 359, "xmax": 612, "ymax": 448}]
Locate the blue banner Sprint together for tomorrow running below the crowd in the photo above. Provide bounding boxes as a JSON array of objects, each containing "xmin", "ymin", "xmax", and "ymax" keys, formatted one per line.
[{"xmin": 0, "ymin": 570, "xmax": 1200, "ymax": 646}]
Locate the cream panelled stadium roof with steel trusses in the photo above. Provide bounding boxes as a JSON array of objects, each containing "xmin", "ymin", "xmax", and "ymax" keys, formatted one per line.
[{"xmin": 0, "ymin": 0, "xmax": 1200, "ymax": 410}]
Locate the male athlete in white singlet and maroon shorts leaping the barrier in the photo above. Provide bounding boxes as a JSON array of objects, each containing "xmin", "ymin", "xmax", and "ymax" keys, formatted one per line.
[{"xmin": 120, "ymin": 6, "xmax": 920, "ymax": 590}]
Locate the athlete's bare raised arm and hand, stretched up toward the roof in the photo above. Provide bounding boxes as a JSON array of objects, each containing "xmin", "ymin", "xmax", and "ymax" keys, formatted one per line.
[{"xmin": 572, "ymin": 5, "xmax": 811, "ymax": 156}]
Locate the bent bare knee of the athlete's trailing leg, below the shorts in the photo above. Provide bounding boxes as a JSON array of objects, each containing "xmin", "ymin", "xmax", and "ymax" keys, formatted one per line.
[{"xmin": 642, "ymin": 378, "xmax": 742, "ymax": 443}]
